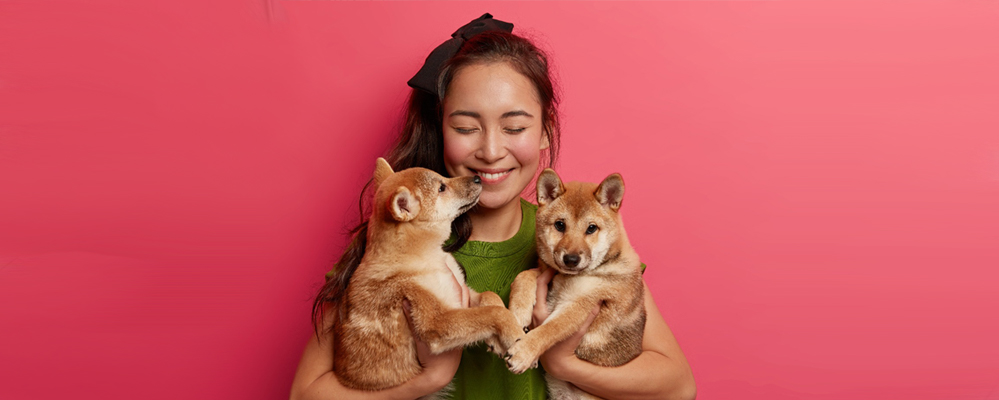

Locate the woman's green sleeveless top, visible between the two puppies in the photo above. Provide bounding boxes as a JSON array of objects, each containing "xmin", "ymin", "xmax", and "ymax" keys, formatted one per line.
[{"xmin": 451, "ymin": 199, "xmax": 548, "ymax": 400}]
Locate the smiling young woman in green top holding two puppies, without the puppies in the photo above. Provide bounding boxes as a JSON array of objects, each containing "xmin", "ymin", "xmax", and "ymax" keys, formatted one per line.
[{"xmin": 291, "ymin": 14, "xmax": 695, "ymax": 399}]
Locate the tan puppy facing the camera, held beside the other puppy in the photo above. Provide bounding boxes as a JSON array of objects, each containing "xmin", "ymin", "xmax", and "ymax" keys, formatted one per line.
[{"xmin": 507, "ymin": 169, "xmax": 645, "ymax": 399}]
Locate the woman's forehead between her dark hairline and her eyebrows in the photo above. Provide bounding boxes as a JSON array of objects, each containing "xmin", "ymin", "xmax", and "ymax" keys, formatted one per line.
[{"xmin": 444, "ymin": 62, "xmax": 541, "ymax": 116}]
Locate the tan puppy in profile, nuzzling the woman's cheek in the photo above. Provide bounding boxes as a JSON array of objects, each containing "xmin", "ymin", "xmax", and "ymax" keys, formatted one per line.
[{"xmin": 333, "ymin": 158, "xmax": 524, "ymax": 398}]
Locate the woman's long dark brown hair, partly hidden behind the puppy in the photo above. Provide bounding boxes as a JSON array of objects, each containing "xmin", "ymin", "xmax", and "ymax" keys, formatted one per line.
[{"xmin": 312, "ymin": 31, "xmax": 560, "ymax": 335}]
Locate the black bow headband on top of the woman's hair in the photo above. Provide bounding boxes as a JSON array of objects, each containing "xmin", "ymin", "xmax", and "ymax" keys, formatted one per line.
[{"xmin": 406, "ymin": 13, "xmax": 513, "ymax": 96}]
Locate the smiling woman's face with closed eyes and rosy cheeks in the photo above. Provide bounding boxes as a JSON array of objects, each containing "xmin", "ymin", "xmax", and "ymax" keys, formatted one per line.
[{"xmin": 443, "ymin": 62, "xmax": 548, "ymax": 209}]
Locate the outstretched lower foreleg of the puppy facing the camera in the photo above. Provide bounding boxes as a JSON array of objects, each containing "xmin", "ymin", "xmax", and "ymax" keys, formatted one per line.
[{"xmin": 506, "ymin": 299, "xmax": 596, "ymax": 374}]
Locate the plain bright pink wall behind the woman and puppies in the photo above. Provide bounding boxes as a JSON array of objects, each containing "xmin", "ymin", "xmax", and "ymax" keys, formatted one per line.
[{"xmin": 0, "ymin": 0, "xmax": 999, "ymax": 399}]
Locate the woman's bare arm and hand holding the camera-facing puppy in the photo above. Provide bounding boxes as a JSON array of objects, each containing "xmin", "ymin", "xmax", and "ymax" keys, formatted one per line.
[{"xmin": 538, "ymin": 274, "xmax": 696, "ymax": 399}]
